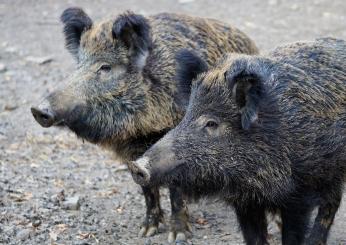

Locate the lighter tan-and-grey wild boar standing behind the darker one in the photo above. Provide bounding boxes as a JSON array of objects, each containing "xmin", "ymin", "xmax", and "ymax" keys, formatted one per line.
[{"xmin": 32, "ymin": 8, "xmax": 257, "ymax": 240}]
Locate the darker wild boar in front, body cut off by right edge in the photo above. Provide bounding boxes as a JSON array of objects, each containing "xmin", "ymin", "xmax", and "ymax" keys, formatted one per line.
[{"xmin": 129, "ymin": 38, "xmax": 346, "ymax": 245}]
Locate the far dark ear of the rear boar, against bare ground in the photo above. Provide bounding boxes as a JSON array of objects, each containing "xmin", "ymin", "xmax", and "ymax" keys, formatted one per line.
[{"xmin": 60, "ymin": 8, "xmax": 92, "ymax": 57}]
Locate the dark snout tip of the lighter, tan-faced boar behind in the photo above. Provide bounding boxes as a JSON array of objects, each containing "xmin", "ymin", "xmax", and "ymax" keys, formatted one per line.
[{"xmin": 31, "ymin": 100, "xmax": 56, "ymax": 128}]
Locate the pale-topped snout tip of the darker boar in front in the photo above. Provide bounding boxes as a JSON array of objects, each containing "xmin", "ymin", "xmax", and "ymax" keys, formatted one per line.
[{"xmin": 129, "ymin": 157, "xmax": 150, "ymax": 186}]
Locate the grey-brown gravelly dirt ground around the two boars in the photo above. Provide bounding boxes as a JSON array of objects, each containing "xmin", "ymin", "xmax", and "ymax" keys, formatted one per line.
[{"xmin": 0, "ymin": 0, "xmax": 346, "ymax": 245}]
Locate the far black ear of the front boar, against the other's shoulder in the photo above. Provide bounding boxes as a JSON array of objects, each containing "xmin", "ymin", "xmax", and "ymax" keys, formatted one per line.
[{"xmin": 175, "ymin": 49, "xmax": 208, "ymax": 106}]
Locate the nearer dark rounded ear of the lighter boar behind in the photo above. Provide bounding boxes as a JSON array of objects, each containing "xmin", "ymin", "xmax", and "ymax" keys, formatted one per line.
[{"xmin": 112, "ymin": 12, "xmax": 151, "ymax": 65}]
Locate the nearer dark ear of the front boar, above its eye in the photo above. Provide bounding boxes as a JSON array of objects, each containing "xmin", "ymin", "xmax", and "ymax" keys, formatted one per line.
[{"xmin": 225, "ymin": 70, "xmax": 264, "ymax": 130}]
